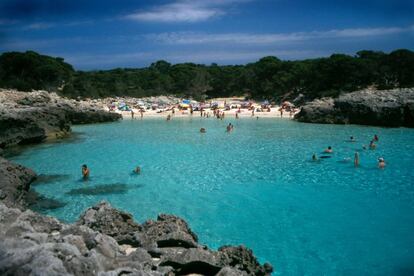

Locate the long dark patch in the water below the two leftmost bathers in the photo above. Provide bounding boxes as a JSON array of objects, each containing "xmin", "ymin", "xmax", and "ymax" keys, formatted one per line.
[{"xmin": 66, "ymin": 183, "xmax": 144, "ymax": 195}]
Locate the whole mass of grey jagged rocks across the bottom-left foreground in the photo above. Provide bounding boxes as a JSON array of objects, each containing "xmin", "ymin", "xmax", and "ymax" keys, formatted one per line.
[{"xmin": 0, "ymin": 199, "xmax": 273, "ymax": 275}]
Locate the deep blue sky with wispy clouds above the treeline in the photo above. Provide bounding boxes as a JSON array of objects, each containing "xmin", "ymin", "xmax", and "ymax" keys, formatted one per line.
[{"xmin": 0, "ymin": 0, "xmax": 414, "ymax": 70}]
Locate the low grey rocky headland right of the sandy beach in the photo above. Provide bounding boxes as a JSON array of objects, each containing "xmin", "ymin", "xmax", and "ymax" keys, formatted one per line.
[{"xmin": 295, "ymin": 88, "xmax": 414, "ymax": 127}]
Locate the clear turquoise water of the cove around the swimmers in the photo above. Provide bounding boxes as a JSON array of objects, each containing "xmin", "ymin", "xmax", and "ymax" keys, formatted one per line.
[{"xmin": 8, "ymin": 118, "xmax": 414, "ymax": 275}]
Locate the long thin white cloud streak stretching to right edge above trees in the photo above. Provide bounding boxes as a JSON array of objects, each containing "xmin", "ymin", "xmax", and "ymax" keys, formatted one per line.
[{"xmin": 147, "ymin": 26, "xmax": 414, "ymax": 45}]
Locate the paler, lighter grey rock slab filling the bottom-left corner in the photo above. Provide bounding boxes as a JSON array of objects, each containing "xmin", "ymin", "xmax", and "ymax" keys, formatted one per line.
[{"xmin": 0, "ymin": 203, "xmax": 162, "ymax": 275}]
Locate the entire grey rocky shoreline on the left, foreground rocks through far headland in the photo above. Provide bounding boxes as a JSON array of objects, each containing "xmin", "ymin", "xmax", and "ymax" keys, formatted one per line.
[{"xmin": 0, "ymin": 90, "xmax": 273, "ymax": 276}]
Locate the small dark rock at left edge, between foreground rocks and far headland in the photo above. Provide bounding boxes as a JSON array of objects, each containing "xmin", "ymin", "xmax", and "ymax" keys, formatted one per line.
[{"xmin": 0, "ymin": 157, "xmax": 36, "ymax": 208}]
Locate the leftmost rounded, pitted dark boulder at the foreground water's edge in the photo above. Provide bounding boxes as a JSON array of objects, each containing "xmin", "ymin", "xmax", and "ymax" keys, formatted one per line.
[{"xmin": 77, "ymin": 202, "xmax": 142, "ymax": 246}]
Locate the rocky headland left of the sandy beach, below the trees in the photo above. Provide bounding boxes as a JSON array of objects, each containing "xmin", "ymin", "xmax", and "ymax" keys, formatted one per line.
[{"xmin": 0, "ymin": 90, "xmax": 121, "ymax": 148}]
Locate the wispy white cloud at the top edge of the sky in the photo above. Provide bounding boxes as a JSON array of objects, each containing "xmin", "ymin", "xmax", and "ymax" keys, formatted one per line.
[{"xmin": 125, "ymin": 0, "xmax": 250, "ymax": 23}]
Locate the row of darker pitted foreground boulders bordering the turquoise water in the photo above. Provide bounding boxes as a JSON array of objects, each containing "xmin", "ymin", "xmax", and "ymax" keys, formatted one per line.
[{"xmin": 77, "ymin": 202, "xmax": 273, "ymax": 275}]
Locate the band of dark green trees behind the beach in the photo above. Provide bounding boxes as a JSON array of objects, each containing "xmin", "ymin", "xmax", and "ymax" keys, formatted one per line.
[{"xmin": 0, "ymin": 49, "xmax": 414, "ymax": 100}]
